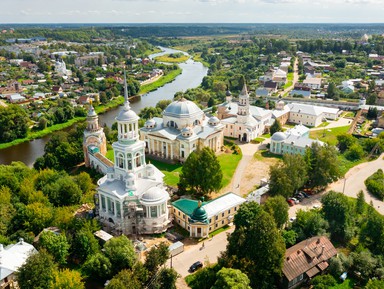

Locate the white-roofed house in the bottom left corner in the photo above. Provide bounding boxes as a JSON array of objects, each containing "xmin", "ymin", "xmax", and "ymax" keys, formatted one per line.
[{"xmin": 0, "ymin": 238, "xmax": 37, "ymax": 289}]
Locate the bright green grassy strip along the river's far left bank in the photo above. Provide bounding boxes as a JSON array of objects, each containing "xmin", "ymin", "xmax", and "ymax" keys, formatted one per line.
[{"xmin": 0, "ymin": 68, "xmax": 182, "ymax": 150}]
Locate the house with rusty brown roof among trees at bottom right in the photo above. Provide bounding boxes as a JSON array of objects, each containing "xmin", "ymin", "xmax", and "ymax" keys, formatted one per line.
[{"xmin": 282, "ymin": 236, "xmax": 337, "ymax": 289}]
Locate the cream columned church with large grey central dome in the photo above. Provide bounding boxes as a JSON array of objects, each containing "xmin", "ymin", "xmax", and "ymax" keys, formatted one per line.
[{"xmin": 140, "ymin": 98, "xmax": 224, "ymax": 162}]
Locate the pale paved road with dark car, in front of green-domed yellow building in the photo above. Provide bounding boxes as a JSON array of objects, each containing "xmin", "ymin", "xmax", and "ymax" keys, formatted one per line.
[{"xmin": 167, "ymin": 227, "xmax": 234, "ymax": 277}]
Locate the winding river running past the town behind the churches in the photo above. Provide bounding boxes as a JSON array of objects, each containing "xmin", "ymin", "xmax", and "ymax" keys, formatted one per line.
[{"xmin": 0, "ymin": 47, "xmax": 208, "ymax": 166}]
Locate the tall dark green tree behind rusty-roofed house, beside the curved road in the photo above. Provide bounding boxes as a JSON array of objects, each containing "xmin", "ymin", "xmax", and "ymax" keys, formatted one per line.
[{"xmin": 321, "ymin": 191, "xmax": 353, "ymax": 242}]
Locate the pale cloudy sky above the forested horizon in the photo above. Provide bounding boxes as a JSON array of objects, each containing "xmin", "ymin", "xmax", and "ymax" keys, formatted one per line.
[{"xmin": 0, "ymin": 0, "xmax": 384, "ymax": 23}]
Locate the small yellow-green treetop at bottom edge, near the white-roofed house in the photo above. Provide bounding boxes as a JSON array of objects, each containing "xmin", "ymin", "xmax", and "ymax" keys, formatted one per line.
[{"xmin": 49, "ymin": 269, "xmax": 85, "ymax": 289}]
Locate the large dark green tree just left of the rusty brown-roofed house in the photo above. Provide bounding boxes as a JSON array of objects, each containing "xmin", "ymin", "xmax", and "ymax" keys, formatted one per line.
[{"xmin": 220, "ymin": 202, "xmax": 285, "ymax": 288}]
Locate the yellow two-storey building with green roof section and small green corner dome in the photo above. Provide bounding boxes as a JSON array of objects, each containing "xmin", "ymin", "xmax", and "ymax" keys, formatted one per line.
[{"xmin": 171, "ymin": 192, "xmax": 245, "ymax": 238}]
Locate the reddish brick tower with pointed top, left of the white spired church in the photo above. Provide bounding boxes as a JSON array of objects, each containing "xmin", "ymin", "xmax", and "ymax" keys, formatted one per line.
[{"xmin": 83, "ymin": 103, "xmax": 107, "ymax": 167}]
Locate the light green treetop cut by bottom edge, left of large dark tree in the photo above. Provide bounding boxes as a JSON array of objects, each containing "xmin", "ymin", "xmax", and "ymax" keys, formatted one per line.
[{"xmin": 212, "ymin": 268, "xmax": 251, "ymax": 289}]
